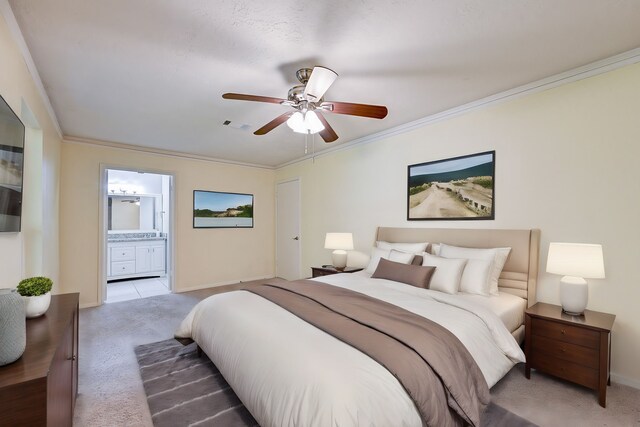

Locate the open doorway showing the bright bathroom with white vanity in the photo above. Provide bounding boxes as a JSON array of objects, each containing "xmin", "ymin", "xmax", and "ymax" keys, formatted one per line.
[{"xmin": 102, "ymin": 168, "xmax": 173, "ymax": 303}]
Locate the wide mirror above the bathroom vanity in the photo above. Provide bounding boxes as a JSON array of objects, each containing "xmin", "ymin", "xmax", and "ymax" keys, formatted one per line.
[{"xmin": 107, "ymin": 194, "xmax": 162, "ymax": 231}]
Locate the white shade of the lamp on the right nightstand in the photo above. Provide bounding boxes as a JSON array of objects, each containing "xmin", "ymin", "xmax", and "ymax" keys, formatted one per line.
[{"xmin": 547, "ymin": 242, "xmax": 604, "ymax": 279}]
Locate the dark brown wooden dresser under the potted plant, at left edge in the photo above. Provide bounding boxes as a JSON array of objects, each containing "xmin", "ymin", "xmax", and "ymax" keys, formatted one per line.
[{"xmin": 0, "ymin": 293, "xmax": 79, "ymax": 427}]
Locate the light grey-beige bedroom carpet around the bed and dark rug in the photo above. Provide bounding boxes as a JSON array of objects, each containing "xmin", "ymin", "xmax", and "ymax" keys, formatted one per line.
[{"xmin": 74, "ymin": 285, "xmax": 640, "ymax": 427}]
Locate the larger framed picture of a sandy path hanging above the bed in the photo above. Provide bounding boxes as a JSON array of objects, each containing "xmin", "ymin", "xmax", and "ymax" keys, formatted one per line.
[{"xmin": 407, "ymin": 151, "xmax": 496, "ymax": 221}]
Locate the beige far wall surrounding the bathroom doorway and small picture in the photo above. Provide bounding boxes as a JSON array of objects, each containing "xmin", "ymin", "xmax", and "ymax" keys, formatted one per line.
[{"xmin": 60, "ymin": 142, "xmax": 275, "ymax": 306}]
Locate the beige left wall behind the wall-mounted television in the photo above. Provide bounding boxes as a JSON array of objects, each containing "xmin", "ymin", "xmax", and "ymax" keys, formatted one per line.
[{"xmin": 0, "ymin": 9, "xmax": 61, "ymax": 292}]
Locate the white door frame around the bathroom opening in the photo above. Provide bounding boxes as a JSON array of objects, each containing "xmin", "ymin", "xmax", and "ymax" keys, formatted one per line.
[{"xmin": 97, "ymin": 163, "xmax": 177, "ymax": 305}]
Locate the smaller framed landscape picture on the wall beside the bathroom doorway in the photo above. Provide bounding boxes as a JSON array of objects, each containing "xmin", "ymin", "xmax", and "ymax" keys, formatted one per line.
[{"xmin": 193, "ymin": 190, "xmax": 253, "ymax": 228}]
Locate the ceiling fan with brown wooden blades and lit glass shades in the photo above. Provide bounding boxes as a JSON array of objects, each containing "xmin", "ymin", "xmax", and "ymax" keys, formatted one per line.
[{"xmin": 222, "ymin": 66, "xmax": 387, "ymax": 142}]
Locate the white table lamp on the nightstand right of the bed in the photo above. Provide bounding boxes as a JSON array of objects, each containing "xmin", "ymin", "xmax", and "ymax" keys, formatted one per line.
[{"xmin": 547, "ymin": 242, "xmax": 604, "ymax": 316}]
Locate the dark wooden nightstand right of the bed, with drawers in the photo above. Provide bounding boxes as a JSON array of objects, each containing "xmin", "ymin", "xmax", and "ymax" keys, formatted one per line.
[{"xmin": 525, "ymin": 302, "xmax": 616, "ymax": 408}]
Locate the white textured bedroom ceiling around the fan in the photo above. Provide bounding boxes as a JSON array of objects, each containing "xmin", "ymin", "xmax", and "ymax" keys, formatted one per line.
[{"xmin": 10, "ymin": 0, "xmax": 640, "ymax": 166}]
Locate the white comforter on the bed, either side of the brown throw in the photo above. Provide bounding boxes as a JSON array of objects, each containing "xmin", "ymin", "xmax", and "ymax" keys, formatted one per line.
[{"xmin": 176, "ymin": 273, "xmax": 524, "ymax": 427}]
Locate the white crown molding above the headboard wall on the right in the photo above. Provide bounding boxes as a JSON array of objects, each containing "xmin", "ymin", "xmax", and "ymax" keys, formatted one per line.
[{"xmin": 275, "ymin": 48, "xmax": 640, "ymax": 169}]
